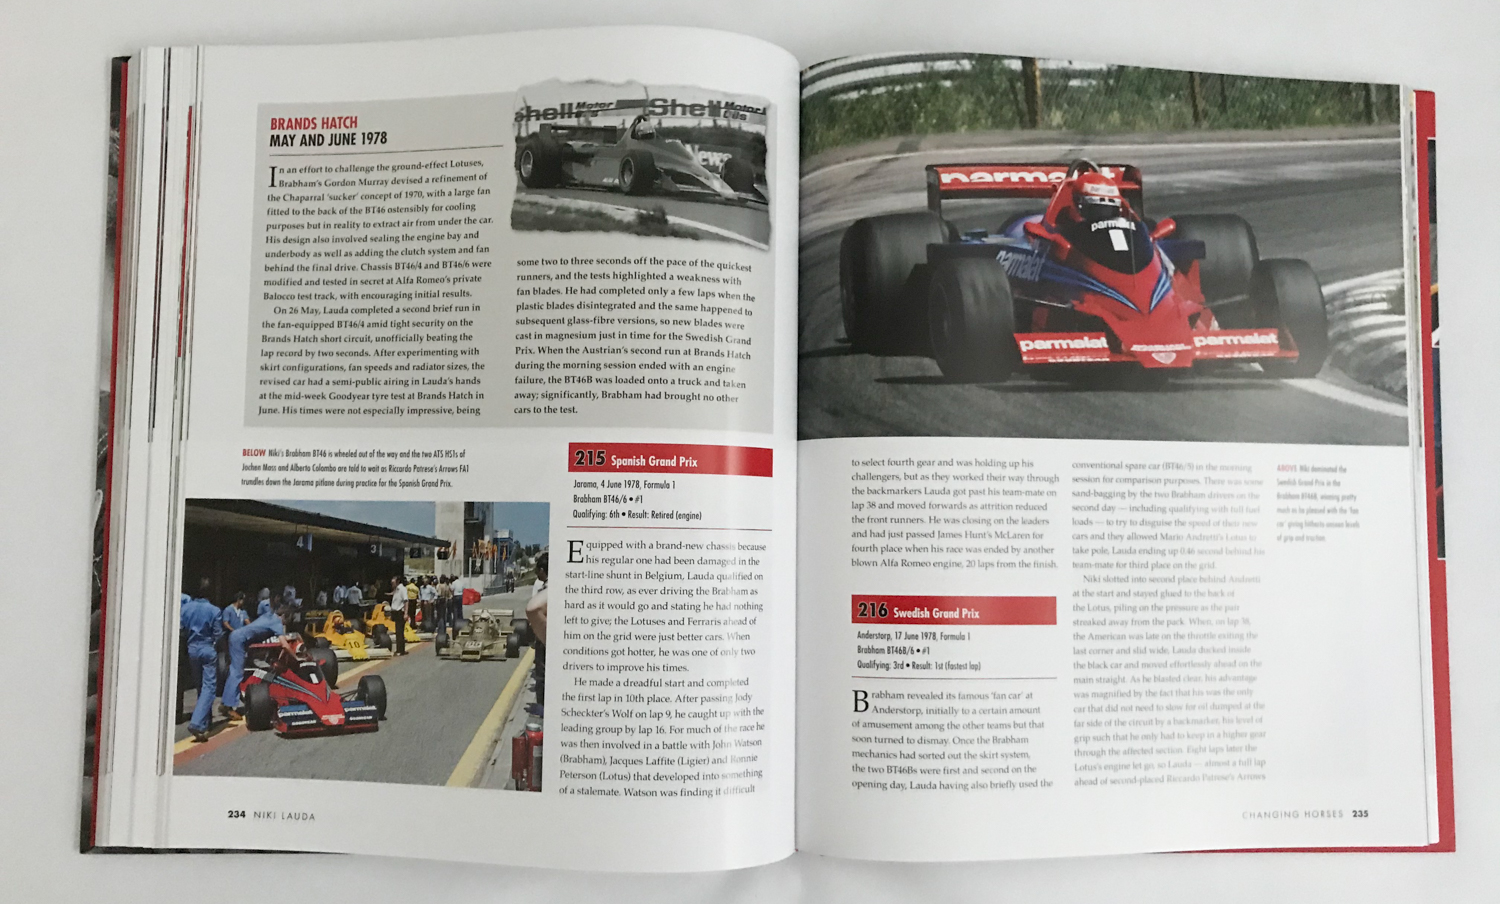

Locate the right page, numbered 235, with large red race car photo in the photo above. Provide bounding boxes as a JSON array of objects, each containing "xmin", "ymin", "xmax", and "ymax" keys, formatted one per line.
[{"xmin": 798, "ymin": 54, "xmax": 1452, "ymax": 861}]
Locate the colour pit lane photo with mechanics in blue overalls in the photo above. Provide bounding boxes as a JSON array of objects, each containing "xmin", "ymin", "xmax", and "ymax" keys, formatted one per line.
[{"xmin": 173, "ymin": 499, "xmax": 551, "ymax": 790}]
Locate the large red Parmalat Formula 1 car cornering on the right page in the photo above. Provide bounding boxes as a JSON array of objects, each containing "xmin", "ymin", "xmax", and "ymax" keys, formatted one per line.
[{"xmin": 839, "ymin": 160, "xmax": 1329, "ymax": 384}]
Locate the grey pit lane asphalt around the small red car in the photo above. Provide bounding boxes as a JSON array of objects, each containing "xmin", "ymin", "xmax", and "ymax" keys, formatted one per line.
[{"xmin": 173, "ymin": 586, "xmax": 530, "ymax": 784}]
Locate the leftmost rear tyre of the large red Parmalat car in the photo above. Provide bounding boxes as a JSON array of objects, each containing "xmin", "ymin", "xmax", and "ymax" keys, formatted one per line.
[{"xmin": 839, "ymin": 211, "xmax": 948, "ymax": 354}]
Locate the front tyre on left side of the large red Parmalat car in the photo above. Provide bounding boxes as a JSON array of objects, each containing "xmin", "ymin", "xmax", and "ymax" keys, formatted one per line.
[{"xmin": 927, "ymin": 258, "xmax": 1022, "ymax": 382}]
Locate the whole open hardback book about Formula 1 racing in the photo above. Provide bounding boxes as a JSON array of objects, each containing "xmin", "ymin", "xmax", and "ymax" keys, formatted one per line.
[{"xmin": 83, "ymin": 28, "xmax": 1454, "ymax": 871}]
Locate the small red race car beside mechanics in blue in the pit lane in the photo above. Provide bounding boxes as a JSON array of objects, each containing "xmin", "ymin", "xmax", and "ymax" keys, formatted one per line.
[{"xmin": 240, "ymin": 634, "xmax": 386, "ymax": 736}]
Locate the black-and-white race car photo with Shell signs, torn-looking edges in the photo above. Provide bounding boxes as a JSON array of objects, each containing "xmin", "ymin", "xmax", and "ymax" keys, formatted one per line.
[{"xmin": 510, "ymin": 79, "xmax": 771, "ymax": 249}]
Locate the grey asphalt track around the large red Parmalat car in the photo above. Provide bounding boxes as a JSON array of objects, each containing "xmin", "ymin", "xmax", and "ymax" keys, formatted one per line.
[{"xmin": 798, "ymin": 138, "xmax": 1407, "ymax": 445}]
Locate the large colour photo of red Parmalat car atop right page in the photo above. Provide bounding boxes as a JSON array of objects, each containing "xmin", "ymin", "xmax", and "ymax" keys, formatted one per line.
[{"xmin": 798, "ymin": 54, "xmax": 1407, "ymax": 445}]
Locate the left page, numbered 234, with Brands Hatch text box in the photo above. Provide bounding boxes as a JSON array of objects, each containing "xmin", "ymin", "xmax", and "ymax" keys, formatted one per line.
[{"xmin": 86, "ymin": 28, "xmax": 797, "ymax": 870}]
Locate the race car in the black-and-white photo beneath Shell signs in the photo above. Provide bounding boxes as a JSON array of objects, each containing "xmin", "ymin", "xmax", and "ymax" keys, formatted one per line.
[{"xmin": 516, "ymin": 115, "xmax": 765, "ymax": 202}]
